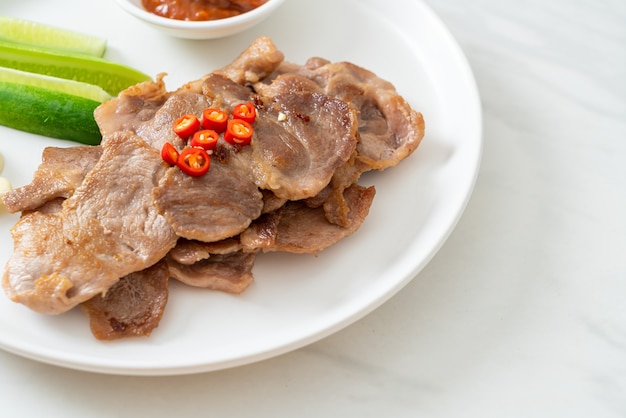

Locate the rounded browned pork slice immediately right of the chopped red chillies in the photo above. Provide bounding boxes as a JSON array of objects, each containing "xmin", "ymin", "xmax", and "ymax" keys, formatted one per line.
[{"xmin": 203, "ymin": 74, "xmax": 357, "ymax": 200}]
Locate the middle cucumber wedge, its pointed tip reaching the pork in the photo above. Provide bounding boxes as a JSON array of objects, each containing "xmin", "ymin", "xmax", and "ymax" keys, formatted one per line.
[{"xmin": 0, "ymin": 41, "xmax": 150, "ymax": 96}]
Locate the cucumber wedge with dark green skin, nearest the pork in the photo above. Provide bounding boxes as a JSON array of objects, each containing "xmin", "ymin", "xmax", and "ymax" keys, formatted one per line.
[{"xmin": 0, "ymin": 67, "xmax": 105, "ymax": 145}]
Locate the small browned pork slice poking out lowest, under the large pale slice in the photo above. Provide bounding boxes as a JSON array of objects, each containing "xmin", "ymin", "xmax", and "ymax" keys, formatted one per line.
[{"xmin": 81, "ymin": 261, "xmax": 170, "ymax": 340}]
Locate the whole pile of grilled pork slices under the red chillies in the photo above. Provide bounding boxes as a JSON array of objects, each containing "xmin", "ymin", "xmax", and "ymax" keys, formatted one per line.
[{"xmin": 3, "ymin": 37, "xmax": 424, "ymax": 339}]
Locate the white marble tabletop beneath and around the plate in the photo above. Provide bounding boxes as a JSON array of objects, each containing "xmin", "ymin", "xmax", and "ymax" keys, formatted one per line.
[{"xmin": 0, "ymin": 0, "xmax": 626, "ymax": 418}]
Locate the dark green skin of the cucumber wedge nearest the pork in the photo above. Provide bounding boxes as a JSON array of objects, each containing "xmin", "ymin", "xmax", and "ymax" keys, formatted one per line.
[{"xmin": 0, "ymin": 82, "xmax": 102, "ymax": 145}]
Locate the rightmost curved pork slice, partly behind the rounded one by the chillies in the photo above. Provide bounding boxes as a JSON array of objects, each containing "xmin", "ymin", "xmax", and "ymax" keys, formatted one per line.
[{"xmin": 253, "ymin": 58, "xmax": 424, "ymax": 227}]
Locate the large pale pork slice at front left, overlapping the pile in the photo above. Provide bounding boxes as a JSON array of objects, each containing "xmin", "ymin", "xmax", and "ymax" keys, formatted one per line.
[{"xmin": 3, "ymin": 132, "xmax": 177, "ymax": 314}]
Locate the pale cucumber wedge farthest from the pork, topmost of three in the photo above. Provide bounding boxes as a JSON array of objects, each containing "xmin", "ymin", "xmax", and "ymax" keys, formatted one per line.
[{"xmin": 0, "ymin": 16, "xmax": 107, "ymax": 57}]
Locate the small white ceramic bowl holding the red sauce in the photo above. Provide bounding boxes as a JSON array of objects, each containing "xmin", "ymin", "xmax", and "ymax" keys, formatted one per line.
[{"xmin": 116, "ymin": 0, "xmax": 284, "ymax": 39}]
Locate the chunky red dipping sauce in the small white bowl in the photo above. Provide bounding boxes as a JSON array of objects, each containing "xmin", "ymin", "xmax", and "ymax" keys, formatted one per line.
[{"xmin": 141, "ymin": 0, "xmax": 267, "ymax": 21}]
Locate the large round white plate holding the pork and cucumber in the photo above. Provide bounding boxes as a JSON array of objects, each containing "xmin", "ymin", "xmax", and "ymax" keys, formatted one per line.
[{"xmin": 0, "ymin": 0, "xmax": 482, "ymax": 375}]
